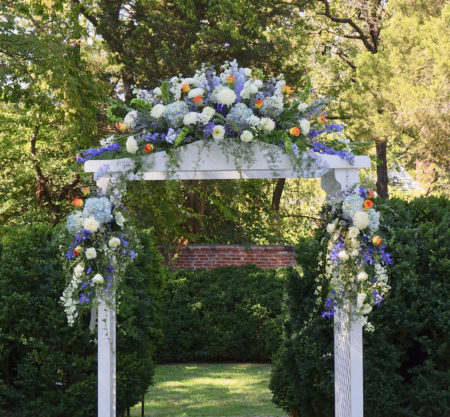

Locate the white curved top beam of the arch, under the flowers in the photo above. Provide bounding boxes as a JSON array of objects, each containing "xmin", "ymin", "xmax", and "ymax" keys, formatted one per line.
[{"xmin": 84, "ymin": 141, "xmax": 370, "ymax": 181}]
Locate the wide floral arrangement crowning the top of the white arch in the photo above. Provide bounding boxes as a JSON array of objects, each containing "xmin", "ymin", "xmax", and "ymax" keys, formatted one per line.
[{"xmin": 77, "ymin": 61, "xmax": 356, "ymax": 163}]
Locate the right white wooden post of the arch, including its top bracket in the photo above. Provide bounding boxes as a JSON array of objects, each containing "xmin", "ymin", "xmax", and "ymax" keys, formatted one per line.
[{"xmin": 322, "ymin": 169, "xmax": 364, "ymax": 417}]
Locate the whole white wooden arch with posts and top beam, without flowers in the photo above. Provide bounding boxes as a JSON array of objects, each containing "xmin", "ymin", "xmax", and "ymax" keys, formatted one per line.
[{"xmin": 84, "ymin": 141, "xmax": 370, "ymax": 417}]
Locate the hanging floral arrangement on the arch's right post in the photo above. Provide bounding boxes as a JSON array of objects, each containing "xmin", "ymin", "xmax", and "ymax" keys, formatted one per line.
[{"xmin": 318, "ymin": 187, "xmax": 392, "ymax": 330}]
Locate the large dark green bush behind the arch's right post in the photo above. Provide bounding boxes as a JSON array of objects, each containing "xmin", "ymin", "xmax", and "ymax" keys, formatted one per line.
[{"xmin": 271, "ymin": 198, "xmax": 450, "ymax": 417}]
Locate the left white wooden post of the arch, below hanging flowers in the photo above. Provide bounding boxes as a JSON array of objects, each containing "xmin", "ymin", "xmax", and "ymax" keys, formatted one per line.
[{"xmin": 97, "ymin": 178, "xmax": 116, "ymax": 417}]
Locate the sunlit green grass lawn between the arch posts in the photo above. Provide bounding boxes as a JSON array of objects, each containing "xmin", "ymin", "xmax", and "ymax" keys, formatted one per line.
[{"xmin": 131, "ymin": 364, "xmax": 286, "ymax": 417}]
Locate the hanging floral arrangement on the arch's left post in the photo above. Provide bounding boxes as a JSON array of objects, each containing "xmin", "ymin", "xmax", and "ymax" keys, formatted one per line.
[{"xmin": 61, "ymin": 187, "xmax": 136, "ymax": 325}]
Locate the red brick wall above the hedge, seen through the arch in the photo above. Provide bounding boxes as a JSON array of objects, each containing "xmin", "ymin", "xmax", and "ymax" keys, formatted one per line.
[{"xmin": 173, "ymin": 245, "xmax": 297, "ymax": 269}]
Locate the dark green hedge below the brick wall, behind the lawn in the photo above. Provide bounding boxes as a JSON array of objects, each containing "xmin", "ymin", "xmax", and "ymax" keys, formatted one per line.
[{"xmin": 158, "ymin": 265, "xmax": 286, "ymax": 362}]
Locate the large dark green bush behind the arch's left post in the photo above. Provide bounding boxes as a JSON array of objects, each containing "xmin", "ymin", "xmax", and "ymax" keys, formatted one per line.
[{"xmin": 0, "ymin": 225, "xmax": 161, "ymax": 417}]
